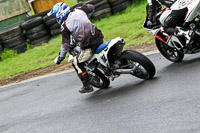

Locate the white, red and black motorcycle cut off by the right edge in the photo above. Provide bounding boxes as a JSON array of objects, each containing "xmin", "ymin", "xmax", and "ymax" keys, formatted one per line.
[{"xmin": 143, "ymin": 0, "xmax": 200, "ymax": 62}]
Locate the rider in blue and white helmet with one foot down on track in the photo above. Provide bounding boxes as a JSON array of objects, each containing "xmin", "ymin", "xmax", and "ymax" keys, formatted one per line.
[{"xmin": 48, "ymin": 2, "xmax": 104, "ymax": 93}]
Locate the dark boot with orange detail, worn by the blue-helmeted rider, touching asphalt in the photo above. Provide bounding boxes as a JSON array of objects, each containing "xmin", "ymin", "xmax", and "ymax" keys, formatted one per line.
[{"xmin": 79, "ymin": 72, "xmax": 94, "ymax": 93}]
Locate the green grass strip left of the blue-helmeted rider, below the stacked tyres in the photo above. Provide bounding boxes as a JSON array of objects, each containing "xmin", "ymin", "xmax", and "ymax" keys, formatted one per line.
[{"xmin": 0, "ymin": 35, "xmax": 61, "ymax": 79}]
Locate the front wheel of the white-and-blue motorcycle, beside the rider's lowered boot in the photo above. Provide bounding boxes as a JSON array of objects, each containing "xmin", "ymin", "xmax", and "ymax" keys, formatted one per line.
[{"xmin": 88, "ymin": 69, "xmax": 110, "ymax": 89}]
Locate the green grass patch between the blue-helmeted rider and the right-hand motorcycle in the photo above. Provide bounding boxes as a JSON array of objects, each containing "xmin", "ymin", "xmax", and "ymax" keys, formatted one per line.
[{"xmin": 93, "ymin": 1, "xmax": 152, "ymax": 45}]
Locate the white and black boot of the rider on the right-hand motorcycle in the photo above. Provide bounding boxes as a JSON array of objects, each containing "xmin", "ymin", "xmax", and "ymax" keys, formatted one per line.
[{"xmin": 174, "ymin": 27, "xmax": 193, "ymax": 45}]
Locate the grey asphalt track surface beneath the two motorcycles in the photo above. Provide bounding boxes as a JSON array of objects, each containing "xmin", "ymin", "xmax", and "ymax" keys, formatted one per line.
[{"xmin": 0, "ymin": 53, "xmax": 200, "ymax": 133}]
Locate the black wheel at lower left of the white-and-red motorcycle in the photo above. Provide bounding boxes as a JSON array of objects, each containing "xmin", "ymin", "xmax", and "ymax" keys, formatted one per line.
[{"xmin": 155, "ymin": 38, "xmax": 184, "ymax": 63}]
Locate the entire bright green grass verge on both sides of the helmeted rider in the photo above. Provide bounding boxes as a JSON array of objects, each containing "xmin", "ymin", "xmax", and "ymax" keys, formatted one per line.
[{"xmin": 0, "ymin": 0, "xmax": 153, "ymax": 79}]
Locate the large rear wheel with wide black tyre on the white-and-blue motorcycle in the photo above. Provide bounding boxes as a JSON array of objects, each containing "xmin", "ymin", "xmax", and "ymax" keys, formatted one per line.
[{"xmin": 120, "ymin": 50, "xmax": 156, "ymax": 80}]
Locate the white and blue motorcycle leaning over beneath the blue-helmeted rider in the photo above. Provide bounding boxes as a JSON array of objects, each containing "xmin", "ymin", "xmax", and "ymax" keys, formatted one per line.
[{"xmin": 68, "ymin": 37, "xmax": 156, "ymax": 89}]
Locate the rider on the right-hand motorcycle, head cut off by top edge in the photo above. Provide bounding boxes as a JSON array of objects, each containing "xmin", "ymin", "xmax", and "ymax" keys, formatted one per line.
[{"xmin": 147, "ymin": 0, "xmax": 192, "ymax": 44}]
